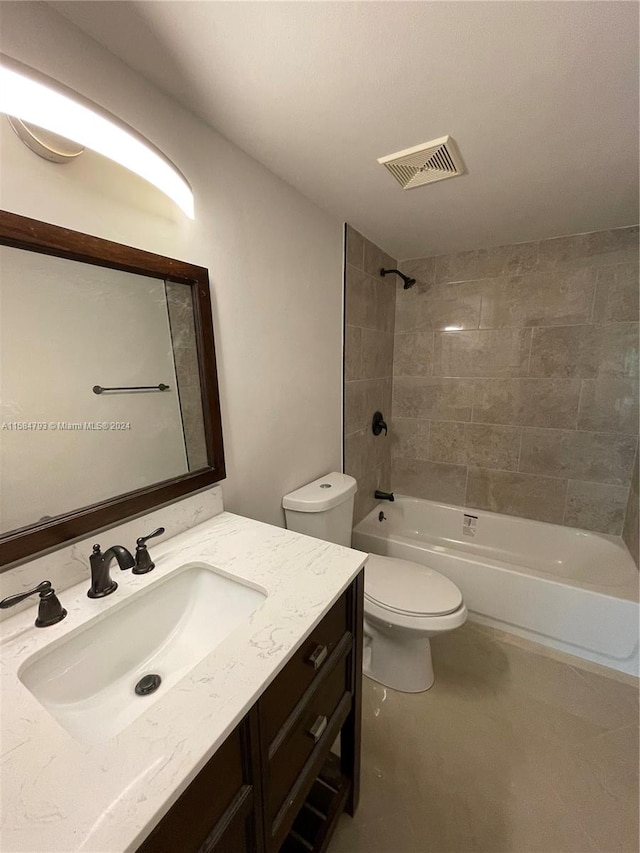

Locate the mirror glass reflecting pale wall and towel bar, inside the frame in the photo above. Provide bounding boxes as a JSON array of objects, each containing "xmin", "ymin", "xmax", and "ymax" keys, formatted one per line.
[{"xmin": 0, "ymin": 246, "xmax": 207, "ymax": 533}]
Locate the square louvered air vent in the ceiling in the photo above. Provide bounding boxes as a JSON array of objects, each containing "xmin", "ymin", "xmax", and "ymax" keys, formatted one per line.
[{"xmin": 378, "ymin": 136, "xmax": 464, "ymax": 190}]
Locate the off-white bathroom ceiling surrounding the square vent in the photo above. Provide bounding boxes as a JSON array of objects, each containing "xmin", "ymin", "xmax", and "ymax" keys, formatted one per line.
[{"xmin": 51, "ymin": 0, "xmax": 638, "ymax": 258}]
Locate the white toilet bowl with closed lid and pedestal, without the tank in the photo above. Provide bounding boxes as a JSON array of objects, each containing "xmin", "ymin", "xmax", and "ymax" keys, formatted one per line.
[{"xmin": 363, "ymin": 554, "xmax": 467, "ymax": 693}]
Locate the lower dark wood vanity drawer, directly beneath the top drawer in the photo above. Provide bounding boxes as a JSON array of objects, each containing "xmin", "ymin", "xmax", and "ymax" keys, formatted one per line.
[{"xmin": 266, "ymin": 659, "xmax": 350, "ymax": 826}]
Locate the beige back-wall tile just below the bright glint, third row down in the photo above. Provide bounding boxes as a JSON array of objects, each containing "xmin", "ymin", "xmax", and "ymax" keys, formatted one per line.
[{"xmin": 433, "ymin": 329, "xmax": 531, "ymax": 376}]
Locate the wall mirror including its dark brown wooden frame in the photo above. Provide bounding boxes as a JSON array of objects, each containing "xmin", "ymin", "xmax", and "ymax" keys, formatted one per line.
[{"xmin": 0, "ymin": 211, "xmax": 225, "ymax": 567}]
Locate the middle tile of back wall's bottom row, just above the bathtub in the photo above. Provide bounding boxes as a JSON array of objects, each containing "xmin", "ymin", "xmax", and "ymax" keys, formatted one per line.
[{"xmin": 466, "ymin": 467, "xmax": 567, "ymax": 524}]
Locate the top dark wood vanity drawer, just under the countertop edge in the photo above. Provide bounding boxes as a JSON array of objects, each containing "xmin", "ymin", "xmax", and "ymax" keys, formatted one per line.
[{"xmin": 260, "ymin": 593, "xmax": 349, "ymax": 746}]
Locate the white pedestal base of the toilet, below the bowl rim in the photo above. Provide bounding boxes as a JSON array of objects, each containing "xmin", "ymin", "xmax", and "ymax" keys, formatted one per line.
[{"xmin": 362, "ymin": 618, "xmax": 434, "ymax": 693}]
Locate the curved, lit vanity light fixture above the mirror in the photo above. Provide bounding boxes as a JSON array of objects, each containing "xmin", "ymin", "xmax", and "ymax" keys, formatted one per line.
[{"xmin": 0, "ymin": 54, "xmax": 194, "ymax": 219}]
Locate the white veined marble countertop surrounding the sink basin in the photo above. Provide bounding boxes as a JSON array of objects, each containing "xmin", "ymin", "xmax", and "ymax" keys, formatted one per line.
[{"xmin": 0, "ymin": 512, "xmax": 366, "ymax": 853}]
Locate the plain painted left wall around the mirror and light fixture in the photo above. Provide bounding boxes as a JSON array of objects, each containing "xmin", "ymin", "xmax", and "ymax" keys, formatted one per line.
[{"xmin": 0, "ymin": 3, "xmax": 342, "ymax": 525}]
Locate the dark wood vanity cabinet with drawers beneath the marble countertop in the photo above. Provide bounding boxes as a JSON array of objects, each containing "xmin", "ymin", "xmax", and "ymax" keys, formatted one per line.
[{"xmin": 138, "ymin": 572, "xmax": 364, "ymax": 853}]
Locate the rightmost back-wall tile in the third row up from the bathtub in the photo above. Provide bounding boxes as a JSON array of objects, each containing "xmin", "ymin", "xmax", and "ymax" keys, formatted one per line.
[{"xmin": 578, "ymin": 375, "xmax": 639, "ymax": 435}]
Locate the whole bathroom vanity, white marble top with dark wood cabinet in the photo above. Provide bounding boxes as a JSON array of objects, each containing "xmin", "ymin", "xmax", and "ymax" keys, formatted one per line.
[{"xmin": 0, "ymin": 512, "xmax": 366, "ymax": 853}]
